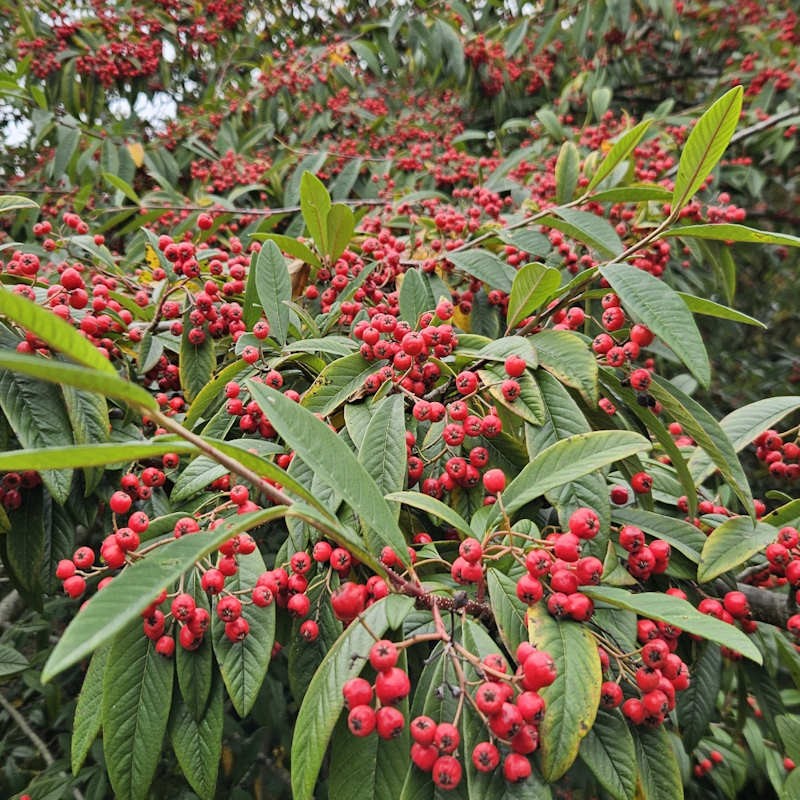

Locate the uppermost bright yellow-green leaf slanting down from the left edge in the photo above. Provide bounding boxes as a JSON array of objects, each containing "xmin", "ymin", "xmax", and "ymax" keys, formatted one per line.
[{"xmin": 0, "ymin": 287, "xmax": 117, "ymax": 377}]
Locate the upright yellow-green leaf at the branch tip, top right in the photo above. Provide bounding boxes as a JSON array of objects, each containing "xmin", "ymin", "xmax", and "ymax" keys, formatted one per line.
[{"xmin": 672, "ymin": 86, "xmax": 743, "ymax": 214}]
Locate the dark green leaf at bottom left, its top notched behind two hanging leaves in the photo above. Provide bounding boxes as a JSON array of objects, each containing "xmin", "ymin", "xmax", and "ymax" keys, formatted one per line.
[{"xmin": 168, "ymin": 680, "xmax": 224, "ymax": 800}]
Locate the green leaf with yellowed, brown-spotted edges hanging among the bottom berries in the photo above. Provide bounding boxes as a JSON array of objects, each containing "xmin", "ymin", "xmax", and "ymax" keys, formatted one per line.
[{"xmin": 528, "ymin": 603, "xmax": 603, "ymax": 782}]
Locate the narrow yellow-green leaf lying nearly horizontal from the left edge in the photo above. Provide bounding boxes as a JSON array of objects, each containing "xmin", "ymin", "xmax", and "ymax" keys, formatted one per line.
[{"xmin": 0, "ymin": 441, "xmax": 197, "ymax": 471}]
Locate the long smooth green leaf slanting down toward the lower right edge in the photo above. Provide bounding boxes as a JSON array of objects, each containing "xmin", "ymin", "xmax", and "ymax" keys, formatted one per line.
[{"xmin": 581, "ymin": 586, "xmax": 762, "ymax": 664}]
